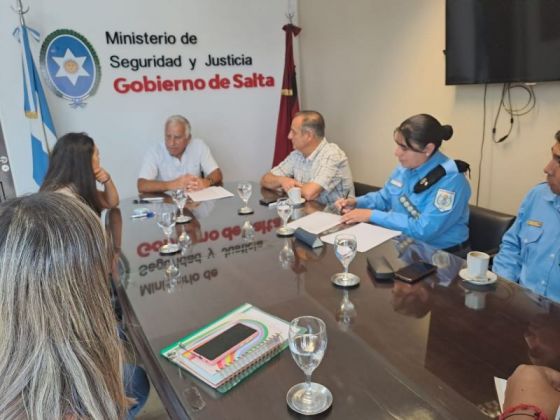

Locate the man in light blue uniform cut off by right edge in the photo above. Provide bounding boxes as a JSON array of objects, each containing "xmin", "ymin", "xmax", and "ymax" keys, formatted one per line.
[{"xmin": 493, "ymin": 131, "xmax": 560, "ymax": 301}]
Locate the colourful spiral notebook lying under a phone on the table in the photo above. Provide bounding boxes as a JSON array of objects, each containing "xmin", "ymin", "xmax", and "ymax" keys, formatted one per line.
[{"xmin": 160, "ymin": 303, "xmax": 290, "ymax": 393}]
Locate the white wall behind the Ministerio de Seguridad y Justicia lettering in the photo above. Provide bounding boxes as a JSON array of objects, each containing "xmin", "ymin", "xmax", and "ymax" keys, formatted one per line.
[{"xmin": 0, "ymin": 0, "xmax": 294, "ymax": 197}]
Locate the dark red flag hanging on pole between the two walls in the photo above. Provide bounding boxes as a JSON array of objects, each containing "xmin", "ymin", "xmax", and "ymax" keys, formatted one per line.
[{"xmin": 272, "ymin": 23, "xmax": 301, "ymax": 166}]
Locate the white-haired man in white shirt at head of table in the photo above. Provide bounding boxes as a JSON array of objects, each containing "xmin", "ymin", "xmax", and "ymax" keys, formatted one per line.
[{"xmin": 138, "ymin": 115, "xmax": 222, "ymax": 193}]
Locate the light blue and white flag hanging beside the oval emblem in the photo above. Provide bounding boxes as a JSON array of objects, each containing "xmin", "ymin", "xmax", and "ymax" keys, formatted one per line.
[{"xmin": 16, "ymin": 25, "xmax": 56, "ymax": 186}]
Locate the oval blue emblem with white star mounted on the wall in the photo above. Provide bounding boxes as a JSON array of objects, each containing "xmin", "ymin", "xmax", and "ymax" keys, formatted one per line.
[{"xmin": 40, "ymin": 29, "xmax": 101, "ymax": 108}]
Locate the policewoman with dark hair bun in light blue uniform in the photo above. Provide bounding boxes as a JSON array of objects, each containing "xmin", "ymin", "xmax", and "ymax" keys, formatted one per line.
[{"xmin": 335, "ymin": 114, "xmax": 471, "ymax": 256}]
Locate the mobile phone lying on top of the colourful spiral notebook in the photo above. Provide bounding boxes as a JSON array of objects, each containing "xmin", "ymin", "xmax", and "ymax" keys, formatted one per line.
[{"xmin": 192, "ymin": 323, "xmax": 257, "ymax": 363}]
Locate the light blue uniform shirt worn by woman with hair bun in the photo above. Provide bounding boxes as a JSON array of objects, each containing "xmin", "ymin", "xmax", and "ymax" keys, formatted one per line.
[{"xmin": 356, "ymin": 152, "xmax": 471, "ymax": 249}]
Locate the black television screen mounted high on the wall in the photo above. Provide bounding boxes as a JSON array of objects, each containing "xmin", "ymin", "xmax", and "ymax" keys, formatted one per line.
[{"xmin": 445, "ymin": 0, "xmax": 560, "ymax": 85}]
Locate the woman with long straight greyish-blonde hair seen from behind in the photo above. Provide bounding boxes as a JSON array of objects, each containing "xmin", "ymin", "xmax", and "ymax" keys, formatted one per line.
[{"xmin": 0, "ymin": 192, "xmax": 149, "ymax": 420}]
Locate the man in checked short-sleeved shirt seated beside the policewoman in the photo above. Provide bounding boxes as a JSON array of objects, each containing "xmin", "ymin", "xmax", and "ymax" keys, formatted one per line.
[{"xmin": 261, "ymin": 111, "xmax": 354, "ymax": 204}]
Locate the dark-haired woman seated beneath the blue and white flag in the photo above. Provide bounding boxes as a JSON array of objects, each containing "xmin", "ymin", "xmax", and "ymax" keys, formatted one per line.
[{"xmin": 41, "ymin": 133, "xmax": 119, "ymax": 213}]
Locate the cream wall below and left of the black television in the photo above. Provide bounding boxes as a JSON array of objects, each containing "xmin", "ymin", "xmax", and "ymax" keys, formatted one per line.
[{"xmin": 298, "ymin": 0, "xmax": 560, "ymax": 213}]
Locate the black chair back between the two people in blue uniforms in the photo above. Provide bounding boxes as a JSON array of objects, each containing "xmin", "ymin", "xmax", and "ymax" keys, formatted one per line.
[{"xmin": 469, "ymin": 205, "xmax": 515, "ymax": 256}]
